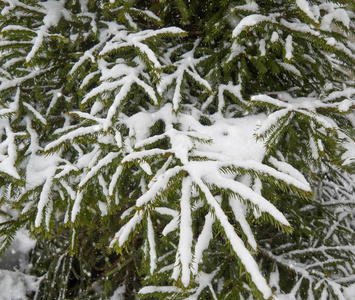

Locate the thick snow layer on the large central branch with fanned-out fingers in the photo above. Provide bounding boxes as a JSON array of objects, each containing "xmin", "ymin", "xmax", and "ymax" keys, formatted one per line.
[{"xmin": 111, "ymin": 103, "xmax": 310, "ymax": 296}]
